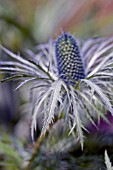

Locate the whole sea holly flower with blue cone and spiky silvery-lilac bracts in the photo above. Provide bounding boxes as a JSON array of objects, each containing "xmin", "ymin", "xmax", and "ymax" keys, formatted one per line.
[{"xmin": 0, "ymin": 33, "xmax": 113, "ymax": 147}]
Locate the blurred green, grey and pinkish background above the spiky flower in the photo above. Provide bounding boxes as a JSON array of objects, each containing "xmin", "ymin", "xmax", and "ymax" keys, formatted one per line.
[{"xmin": 0, "ymin": 0, "xmax": 113, "ymax": 51}]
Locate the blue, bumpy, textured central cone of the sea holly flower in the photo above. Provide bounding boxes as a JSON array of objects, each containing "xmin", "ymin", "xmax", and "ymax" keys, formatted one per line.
[{"xmin": 55, "ymin": 33, "xmax": 85, "ymax": 85}]
